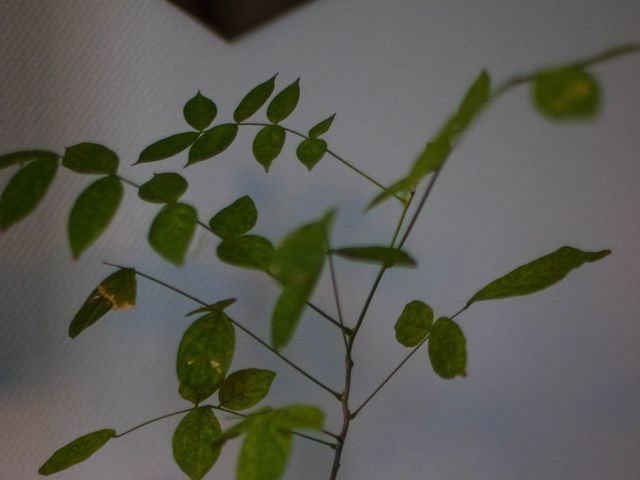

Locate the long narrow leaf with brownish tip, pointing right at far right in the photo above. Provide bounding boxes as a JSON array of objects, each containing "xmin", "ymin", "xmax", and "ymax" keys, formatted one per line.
[{"xmin": 465, "ymin": 246, "xmax": 611, "ymax": 308}]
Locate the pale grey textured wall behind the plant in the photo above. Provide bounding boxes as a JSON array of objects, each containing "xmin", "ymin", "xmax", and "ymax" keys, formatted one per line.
[{"xmin": 0, "ymin": 0, "xmax": 640, "ymax": 480}]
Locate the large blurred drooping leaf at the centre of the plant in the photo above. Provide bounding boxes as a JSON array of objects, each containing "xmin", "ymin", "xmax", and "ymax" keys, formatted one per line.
[{"xmin": 271, "ymin": 212, "xmax": 335, "ymax": 349}]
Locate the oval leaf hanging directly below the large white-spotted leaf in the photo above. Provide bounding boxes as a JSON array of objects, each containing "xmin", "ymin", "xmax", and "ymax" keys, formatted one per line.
[{"xmin": 172, "ymin": 407, "xmax": 222, "ymax": 480}]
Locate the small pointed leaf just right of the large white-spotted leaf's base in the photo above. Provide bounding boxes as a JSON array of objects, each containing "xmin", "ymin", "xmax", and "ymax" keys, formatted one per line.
[{"xmin": 218, "ymin": 368, "xmax": 276, "ymax": 410}]
